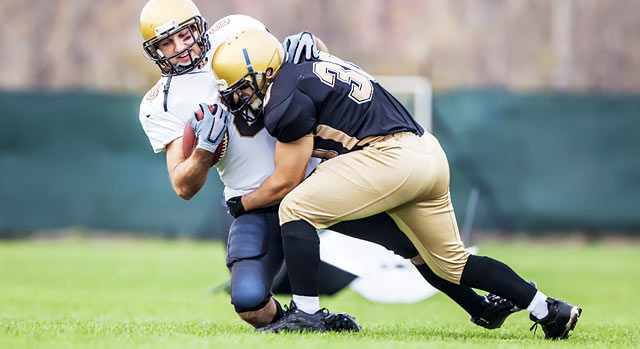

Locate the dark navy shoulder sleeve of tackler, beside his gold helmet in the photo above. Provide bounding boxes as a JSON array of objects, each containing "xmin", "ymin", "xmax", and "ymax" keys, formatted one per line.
[{"xmin": 265, "ymin": 89, "xmax": 316, "ymax": 143}]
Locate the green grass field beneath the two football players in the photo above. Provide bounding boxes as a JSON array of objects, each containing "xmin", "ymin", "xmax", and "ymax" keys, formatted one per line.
[{"xmin": 0, "ymin": 239, "xmax": 640, "ymax": 349}]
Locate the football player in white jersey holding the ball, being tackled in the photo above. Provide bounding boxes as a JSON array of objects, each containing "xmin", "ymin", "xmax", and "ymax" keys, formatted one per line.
[{"xmin": 139, "ymin": 0, "xmax": 528, "ymax": 330}]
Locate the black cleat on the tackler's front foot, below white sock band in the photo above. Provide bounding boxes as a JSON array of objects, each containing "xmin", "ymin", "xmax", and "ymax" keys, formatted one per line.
[{"xmin": 256, "ymin": 301, "xmax": 329, "ymax": 333}]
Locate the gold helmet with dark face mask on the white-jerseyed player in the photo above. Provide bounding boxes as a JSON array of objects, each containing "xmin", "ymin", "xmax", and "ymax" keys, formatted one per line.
[{"xmin": 140, "ymin": 0, "xmax": 209, "ymax": 75}]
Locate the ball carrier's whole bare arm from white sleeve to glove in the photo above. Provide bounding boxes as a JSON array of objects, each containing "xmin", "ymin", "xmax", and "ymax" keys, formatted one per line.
[{"xmin": 167, "ymin": 137, "xmax": 213, "ymax": 200}]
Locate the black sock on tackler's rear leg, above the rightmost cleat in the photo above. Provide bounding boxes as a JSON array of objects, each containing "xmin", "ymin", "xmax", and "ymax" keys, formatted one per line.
[{"xmin": 460, "ymin": 255, "xmax": 537, "ymax": 309}]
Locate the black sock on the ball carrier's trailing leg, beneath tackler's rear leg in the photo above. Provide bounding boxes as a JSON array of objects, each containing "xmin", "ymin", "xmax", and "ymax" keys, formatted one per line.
[{"xmin": 415, "ymin": 263, "xmax": 483, "ymax": 317}]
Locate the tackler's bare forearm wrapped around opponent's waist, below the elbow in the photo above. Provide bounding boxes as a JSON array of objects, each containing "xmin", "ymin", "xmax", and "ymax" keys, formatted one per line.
[{"xmin": 242, "ymin": 175, "xmax": 301, "ymax": 211}]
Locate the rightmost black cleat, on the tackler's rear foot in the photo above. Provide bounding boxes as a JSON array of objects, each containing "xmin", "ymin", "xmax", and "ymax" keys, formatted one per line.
[{"xmin": 529, "ymin": 298, "xmax": 582, "ymax": 339}]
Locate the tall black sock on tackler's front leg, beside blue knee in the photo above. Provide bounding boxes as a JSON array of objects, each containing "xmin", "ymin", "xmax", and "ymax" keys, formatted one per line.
[{"xmin": 281, "ymin": 220, "xmax": 320, "ymax": 296}]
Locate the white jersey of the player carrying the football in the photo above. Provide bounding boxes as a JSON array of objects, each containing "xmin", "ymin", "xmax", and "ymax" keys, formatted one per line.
[{"xmin": 139, "ymin": 16, "xmax": 319, "ymax": 200}]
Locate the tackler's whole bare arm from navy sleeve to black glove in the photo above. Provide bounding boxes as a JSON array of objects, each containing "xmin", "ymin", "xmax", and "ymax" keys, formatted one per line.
[{"xmin": 241, "ymin": 134, "xmax": 313, "ymax": 211}]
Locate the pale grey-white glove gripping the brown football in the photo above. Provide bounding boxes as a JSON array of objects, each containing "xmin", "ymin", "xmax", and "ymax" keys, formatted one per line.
[{"xmin": 189, "ymin": 103, "xmax": 231, "ymax": 153}]
